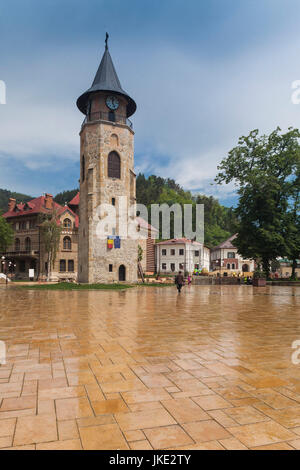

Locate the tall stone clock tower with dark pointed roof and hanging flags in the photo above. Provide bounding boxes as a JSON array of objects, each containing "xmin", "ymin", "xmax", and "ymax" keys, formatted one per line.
[{"xmin": 77, "ymin": 35, "xmax": 138, "ymax": 283}]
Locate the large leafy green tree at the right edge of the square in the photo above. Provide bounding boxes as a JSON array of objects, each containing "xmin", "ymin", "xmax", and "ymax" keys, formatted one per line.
[{"xmin": 215, "ymin": 127, "xmax": 300, "ymax": 276}]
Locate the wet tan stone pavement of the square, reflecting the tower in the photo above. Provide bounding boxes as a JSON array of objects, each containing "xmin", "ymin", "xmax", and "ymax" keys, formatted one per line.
[{"xmin": 0, "ymin": 286, "xmax": 300, "ymax": 449}]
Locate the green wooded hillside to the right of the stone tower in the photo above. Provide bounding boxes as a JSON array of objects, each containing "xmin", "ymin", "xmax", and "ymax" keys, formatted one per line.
[{"xmin": 136, "ymin": 174, "xmax": 236, "ymax": 247}]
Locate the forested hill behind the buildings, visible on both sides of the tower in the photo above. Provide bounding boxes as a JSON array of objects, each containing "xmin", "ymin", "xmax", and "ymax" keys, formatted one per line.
[{"xmin": 0, "ymin": 174, "xmax": 236, "ymax": 247}]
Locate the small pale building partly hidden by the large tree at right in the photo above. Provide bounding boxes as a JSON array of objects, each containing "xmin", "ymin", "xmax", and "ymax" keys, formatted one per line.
[{"xmin": 211, "ymin": 234, "xmax": 254, "ymax": 274}]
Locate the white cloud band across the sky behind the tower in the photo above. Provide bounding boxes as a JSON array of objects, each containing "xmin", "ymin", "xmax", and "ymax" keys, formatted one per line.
[{"xmin": 0, "ymin": 25, "xmax": 300, "ymax": 202}]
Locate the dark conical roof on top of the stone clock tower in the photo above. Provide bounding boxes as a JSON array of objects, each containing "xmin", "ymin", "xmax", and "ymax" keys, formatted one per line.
[{"xmin": 77, "ymin": 40, "xmax": 136, "ymax": 117}]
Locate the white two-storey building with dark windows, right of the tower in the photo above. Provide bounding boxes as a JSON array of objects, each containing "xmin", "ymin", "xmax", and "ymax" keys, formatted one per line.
[{"xmin": 155, "ymin": 238, "xmax": 210, "ymax": 274}]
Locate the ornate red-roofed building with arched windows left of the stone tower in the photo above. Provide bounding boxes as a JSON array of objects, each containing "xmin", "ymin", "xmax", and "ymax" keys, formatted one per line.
[{"xmin": 0, "ymin": 194, "xmax": 78, "ymax": 280}]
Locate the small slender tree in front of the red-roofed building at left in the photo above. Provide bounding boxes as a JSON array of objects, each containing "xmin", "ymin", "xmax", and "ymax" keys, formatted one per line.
[{"xmin": 40, "ymin": 211, "xmax": 62, "ymax": 281}]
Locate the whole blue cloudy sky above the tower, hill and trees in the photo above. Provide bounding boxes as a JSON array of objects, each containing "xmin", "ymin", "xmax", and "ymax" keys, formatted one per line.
[{"xmin": 0, "ymin": 0, "xmax": 300, "ymax": 205}]
